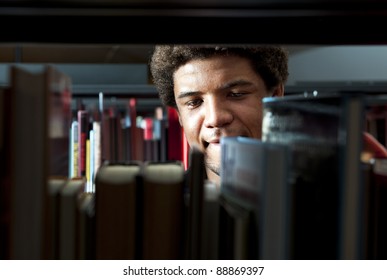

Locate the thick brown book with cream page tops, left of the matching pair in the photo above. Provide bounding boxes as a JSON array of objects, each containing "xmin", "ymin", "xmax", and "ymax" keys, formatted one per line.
[{"xmin": 95, "ymin": 161, "xmax": 142, "ymax": 260}]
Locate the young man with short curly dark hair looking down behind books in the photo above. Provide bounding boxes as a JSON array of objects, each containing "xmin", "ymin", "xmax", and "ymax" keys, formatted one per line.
[{"xmin": 150, "ymin": 45, "xmax": 288, "ymax": 185}]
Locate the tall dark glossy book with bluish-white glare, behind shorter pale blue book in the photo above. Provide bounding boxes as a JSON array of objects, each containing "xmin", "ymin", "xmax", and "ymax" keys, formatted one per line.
[{"xmin": 262, "ymin": 96, "xmax": 342, "ymax": 259}]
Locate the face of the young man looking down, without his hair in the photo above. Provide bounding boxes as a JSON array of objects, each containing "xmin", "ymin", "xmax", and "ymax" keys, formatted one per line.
[{"xmin": 174, "ymin": 57, "xmax": 280, "ymax": 183}]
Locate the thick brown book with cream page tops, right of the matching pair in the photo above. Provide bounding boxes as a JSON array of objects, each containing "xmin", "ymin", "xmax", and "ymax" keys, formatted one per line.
[{"xmin": 141, "ymin": 161, "xmax": 184, "ymax": 260}]
